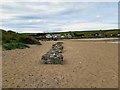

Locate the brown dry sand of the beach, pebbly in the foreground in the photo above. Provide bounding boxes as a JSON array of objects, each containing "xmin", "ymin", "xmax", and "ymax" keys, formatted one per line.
[{"xmin": 2, "ymin": 40, "xmax": 118, "ymax": 88}]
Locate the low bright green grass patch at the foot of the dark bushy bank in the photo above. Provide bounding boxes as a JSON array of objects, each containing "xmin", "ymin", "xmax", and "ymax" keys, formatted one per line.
[{"xmin": 3, "ymin": 43, "xmax": 29, "ymax": 50}]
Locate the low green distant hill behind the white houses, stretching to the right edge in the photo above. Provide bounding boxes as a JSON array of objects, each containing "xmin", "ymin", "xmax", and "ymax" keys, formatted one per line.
[{"xmin": 20, "ymin": 29, "xmax": 120, "ymax": 38}]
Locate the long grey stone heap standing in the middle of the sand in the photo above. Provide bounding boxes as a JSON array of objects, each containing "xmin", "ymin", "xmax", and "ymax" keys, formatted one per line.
[{"xmin": 41, "ymin": 42, "xmax": 63, "ymax": 64}]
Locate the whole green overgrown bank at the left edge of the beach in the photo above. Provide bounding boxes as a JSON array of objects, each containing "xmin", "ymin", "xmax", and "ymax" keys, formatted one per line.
[{"xmin": 0, "ymin": 29, "xmax": 41, "ymax": 50}]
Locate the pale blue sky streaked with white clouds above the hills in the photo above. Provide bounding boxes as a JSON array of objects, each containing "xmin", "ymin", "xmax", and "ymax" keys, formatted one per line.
[{"xmin": 0, "ymin": 1, "xmax": 118, "ymax": 33}]
